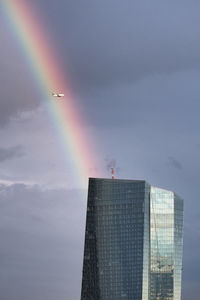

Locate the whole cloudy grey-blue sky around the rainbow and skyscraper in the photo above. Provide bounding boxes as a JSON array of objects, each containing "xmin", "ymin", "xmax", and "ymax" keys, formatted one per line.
[{"xmin": 0, "ymin": 0, "xmax": 200, "ymax": 300}]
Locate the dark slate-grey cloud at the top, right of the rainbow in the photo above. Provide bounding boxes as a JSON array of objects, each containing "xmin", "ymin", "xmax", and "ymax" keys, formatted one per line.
[{"xmin": 35, "ymin": 0, "xmax": 200, "ymax": 90}]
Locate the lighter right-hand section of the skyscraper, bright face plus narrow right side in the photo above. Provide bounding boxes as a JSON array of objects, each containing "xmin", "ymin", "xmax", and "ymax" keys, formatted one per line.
[{"xmin": 150, "ymin": 187, "xmax": 183, "ymax": 300}]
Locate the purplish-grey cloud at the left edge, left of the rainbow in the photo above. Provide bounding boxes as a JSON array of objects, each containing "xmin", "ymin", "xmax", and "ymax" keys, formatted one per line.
[{"xmin": 0, "ymin": 23, "xmax": 42, "ymax": 127}]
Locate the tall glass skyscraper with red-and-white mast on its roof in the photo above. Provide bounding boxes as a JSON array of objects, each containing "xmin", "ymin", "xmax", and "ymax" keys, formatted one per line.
[{"xmin": 81, "ymin": 178, "xmax": 183, "ymax": 300}]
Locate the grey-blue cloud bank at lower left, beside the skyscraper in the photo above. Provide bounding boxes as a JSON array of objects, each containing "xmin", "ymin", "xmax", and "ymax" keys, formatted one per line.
[{"xmin": 0, "ymin": 184, "xmax": 86, "ymax": 300}]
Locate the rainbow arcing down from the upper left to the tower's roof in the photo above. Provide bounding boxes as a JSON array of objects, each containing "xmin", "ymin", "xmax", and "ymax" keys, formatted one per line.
[{"xmin": 2, "ymin": 0, "xmax": 100, "ymax": 187}]
